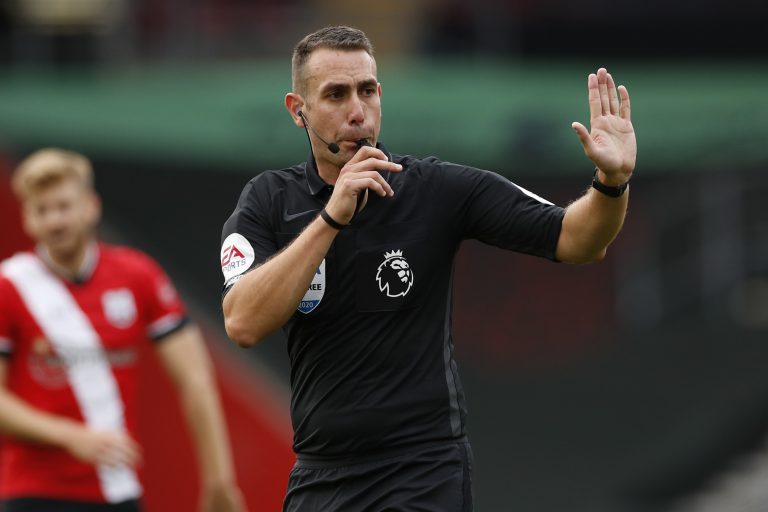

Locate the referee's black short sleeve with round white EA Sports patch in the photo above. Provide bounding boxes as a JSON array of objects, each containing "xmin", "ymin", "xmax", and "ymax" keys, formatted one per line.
[{"xmin": 220, "ymin": 174, "xmax": 277, "ymax": 295}]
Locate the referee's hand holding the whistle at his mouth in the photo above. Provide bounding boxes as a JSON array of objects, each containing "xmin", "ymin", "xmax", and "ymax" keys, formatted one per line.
[{"xmin": 325, "ymin": 146, "xmax": 403, "ymax": 224}]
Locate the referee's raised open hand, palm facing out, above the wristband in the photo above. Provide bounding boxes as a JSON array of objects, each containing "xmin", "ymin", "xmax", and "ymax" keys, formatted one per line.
[{"xmin": 571, "ymin": 68, "xmax": 637, "ymax": 185}]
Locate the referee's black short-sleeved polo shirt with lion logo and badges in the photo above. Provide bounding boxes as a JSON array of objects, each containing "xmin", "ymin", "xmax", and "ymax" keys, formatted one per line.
[{"xmin": 222, "ymin": 145, "xmax": 564, "ymax": 458}]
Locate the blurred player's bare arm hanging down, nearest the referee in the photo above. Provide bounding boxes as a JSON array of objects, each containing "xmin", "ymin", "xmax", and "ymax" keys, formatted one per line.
[{"xmin": 157, "ymin": 324, "xmax": 246, "ymax": 512}]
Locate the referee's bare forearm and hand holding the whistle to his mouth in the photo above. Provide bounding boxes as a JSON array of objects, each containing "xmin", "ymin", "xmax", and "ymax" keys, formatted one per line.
[{"xmin": 222, "ymin": 147, "xmax": 402, "ymax": 347}]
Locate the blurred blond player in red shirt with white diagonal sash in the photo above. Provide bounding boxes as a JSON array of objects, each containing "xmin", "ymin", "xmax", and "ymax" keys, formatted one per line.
[{"xmin": 0, "ymin": 149, "xmax": 245, "ymax": 512}]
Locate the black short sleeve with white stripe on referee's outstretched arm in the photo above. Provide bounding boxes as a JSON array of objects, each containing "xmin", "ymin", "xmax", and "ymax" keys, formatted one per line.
[{"xmin": 440, "ymin": 162, "xmax": 565, "ymax": 260}]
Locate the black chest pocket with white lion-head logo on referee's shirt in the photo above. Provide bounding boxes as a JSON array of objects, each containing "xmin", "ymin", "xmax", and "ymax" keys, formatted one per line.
[{"xmin": 354, "ymin": 223, "xmax": 429, "ymax": 312}]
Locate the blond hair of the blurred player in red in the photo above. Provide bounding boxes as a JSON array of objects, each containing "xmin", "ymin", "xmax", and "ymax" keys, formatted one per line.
[{"xmin": 11, "ymin": 148, "xmax": 93, "ymax": 201}]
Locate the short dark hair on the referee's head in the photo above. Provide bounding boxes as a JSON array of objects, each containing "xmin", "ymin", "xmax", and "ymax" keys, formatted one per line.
[{"xmin": 291, "ymin": 26, "xmax": 373, "ymax": 94}]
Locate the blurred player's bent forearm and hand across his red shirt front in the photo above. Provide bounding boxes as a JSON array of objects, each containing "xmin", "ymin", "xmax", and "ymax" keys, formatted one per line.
[{"xmin": 0, "ymin": 357, "xmax": 141, "ymax": 466}]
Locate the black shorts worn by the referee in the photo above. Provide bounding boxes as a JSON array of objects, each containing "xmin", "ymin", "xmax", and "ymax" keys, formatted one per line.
[{"xmin": 283, "ymin": 440, "xmax": 472, "ymax": 512}]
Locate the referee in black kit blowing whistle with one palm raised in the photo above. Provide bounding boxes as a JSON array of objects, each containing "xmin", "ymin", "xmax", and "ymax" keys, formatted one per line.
[{"xmin": 221, "ymin": 27, "xmax": 636, "ymax": 512}]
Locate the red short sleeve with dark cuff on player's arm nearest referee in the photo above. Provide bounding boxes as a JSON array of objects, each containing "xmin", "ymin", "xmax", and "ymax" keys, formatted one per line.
[{"xmin": 133, "ymin": 255, "xmax": 188, "ymax": 340}]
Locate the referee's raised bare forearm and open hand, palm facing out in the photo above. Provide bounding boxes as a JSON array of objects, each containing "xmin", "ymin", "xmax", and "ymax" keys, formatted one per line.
[{"xmin": 556, "ymin": 68, "xmax": 637, "ymax": 263}]
